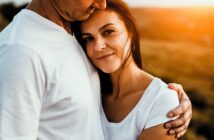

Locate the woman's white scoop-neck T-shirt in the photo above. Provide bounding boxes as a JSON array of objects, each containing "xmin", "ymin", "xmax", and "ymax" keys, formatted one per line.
[{"xmin": 101, "ymin": 78, "xmax": 179, "ymax": 140}]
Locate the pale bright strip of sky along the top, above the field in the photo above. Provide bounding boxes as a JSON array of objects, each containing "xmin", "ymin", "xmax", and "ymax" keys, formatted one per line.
[{"xmin": 0, "ymin": 0, "xmax": 214, "ymax": 7}]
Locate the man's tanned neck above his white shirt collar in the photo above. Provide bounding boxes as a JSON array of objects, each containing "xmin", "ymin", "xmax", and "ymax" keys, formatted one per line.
[{"xmin": 27, "ymin": 0, "xmax": 72, "ymax": 33}]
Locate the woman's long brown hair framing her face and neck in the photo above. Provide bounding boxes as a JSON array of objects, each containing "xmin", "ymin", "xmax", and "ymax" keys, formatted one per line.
[{"xmin": 71, "ymin": 0, "xmax": 142, "ymax": 93}]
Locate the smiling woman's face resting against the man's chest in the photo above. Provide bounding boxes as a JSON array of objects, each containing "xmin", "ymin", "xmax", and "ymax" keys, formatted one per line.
[{"xmin": 81, "ymin": 10, "xmax": 131, "ymax": 73}]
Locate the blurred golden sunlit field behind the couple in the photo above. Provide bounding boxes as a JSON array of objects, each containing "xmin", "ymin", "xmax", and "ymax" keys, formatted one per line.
[{"xmin": 0, "ymin": 3, "xmax": 214, "ymax": 140}]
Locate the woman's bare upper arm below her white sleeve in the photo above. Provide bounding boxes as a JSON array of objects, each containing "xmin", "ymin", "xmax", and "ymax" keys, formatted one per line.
[{"xmin": 138, "ymin": 124, "xmax": 176, "ymax": 140}]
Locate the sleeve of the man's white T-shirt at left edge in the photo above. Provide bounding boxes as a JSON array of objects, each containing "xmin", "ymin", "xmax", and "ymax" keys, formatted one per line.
[{"xmin": 0, "ymin": 46, "xmax": 45, "ymax": 140}]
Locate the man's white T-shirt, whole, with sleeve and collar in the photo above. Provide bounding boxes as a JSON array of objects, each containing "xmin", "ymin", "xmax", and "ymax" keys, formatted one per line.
[{"xmin": 0, "ymin": 9, "xmax": 104, "ymax": 140}]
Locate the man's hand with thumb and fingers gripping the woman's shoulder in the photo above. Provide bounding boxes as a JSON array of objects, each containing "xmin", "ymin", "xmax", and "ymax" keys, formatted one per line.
[{"xmin": 164, "ymin": 83, "xmax": 192, "ymax": 138}]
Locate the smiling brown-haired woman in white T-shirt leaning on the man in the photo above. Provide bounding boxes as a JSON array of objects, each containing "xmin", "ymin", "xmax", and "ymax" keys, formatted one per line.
[{"xmin": 72, "ymin": 0, "xmax": 185, "ymax": 140}]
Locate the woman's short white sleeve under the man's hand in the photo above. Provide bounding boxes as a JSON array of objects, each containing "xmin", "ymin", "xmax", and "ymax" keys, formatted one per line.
[{"xmin": 144, "ymin": 87, "xmax": 179, "ymax": 129}]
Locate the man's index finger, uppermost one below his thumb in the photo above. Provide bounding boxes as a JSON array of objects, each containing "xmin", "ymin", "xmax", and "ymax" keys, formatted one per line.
[{"xmin": 167, "ymin": 99, "xmax": 191, "ymax": 118}]
